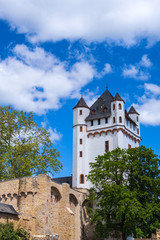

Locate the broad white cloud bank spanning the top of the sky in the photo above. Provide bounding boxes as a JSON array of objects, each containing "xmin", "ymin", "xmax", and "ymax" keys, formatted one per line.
[{"xmin": 0, "ymin": 0, "xmax": 160, "ymax": 45}]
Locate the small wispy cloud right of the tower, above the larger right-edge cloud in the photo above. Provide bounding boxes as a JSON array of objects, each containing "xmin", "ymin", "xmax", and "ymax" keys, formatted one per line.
[{"xmin": 122, "ymin": 55, "xmax": 152, "ymax": 81}]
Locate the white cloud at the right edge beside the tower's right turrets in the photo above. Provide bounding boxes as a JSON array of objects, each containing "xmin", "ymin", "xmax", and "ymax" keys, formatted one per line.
[{"xmin": 134, "ymin": 83, "xmax": 160, "ymax": 126}]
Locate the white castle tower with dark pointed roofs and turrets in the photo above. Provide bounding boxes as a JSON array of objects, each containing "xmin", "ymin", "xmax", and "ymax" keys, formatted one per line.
[{"xmin": 72, "ymin": 89, "xmax": 141, "ymax": 189}]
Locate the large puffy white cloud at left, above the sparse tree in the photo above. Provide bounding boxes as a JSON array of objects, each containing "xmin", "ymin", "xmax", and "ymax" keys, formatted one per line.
[{"xmin": 0, "ymin": 45, "xmax": 96, "ymax": 114}]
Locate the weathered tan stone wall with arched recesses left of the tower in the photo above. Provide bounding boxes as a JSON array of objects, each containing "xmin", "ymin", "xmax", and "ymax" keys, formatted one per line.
[{"xmin": 0, "ymin": 174, "xmax": 90, "ymax": 240}]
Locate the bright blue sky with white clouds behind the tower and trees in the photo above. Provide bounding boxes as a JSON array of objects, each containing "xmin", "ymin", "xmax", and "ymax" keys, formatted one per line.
[{"xmin": 0, "ymin": 0, "xmax": 160, "ymax": 177}]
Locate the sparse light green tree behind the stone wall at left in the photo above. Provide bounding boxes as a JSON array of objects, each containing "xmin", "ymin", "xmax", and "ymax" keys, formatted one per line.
[{"xmin": 0, "ymin": 106, "xmax": 62, "ymax": 180}]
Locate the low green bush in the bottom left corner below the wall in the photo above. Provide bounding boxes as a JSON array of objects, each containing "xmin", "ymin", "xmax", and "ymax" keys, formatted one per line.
[{"xmin": 0, "ymin": 222, "xmax": 30, "ymax": 240}]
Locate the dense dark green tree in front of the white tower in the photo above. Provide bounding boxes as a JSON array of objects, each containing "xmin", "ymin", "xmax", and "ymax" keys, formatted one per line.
[{"xmin": 88, "ymin": 146, "xmax": 160, "ymax": 240}]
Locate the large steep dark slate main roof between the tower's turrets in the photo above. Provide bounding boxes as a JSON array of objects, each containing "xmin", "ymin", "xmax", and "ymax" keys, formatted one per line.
[{"xmin": 86, "ymin": 89, "xmax": 113, "ymax": 121}]
